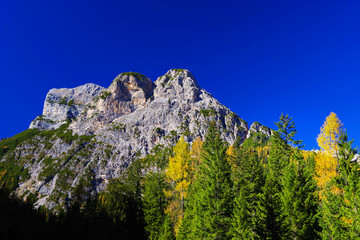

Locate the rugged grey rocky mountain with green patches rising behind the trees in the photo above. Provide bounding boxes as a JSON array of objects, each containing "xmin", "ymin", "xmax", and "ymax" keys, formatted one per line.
[{"xmin": 0, "ymin": 69, "xmax": 271, "ymax": 209}]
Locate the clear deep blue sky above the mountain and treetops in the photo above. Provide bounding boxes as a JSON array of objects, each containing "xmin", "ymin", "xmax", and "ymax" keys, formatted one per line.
[{"xmin": 0, "ymin": 0, "xmax": 360, "ymax": 149}]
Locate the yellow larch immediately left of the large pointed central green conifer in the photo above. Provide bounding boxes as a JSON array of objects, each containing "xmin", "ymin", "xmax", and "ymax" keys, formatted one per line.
[{"xmin": 164, "ymin": 137, "xmax": 191, "ymax": 234}]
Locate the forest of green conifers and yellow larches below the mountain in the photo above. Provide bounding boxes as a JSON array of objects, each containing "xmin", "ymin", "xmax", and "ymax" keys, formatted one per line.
[{"xmin": 0, "ymin": 113, "xmax": 360, "ymax": 240}]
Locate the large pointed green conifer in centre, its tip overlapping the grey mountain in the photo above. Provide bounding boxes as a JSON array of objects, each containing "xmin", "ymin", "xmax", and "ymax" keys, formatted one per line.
[{"xmin": 182, "ymin": 125, "xmax": 233, "ymax": 239}]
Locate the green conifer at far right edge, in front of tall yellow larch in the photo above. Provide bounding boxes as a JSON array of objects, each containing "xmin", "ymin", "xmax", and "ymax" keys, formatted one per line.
[{"xmin": 321, "ymin": 132, "xmax": 360, "ymax": 239}]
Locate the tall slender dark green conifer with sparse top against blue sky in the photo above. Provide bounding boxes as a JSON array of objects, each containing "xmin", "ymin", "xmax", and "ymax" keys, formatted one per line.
[{"xmin": 259, "ymin": 114, "xmax": 301, "ymax": 239}]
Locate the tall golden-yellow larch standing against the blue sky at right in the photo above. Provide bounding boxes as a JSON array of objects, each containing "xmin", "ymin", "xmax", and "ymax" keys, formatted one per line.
[{"xmin": 315, "ymin": 112, "xmax": 343, "ymax": 197}]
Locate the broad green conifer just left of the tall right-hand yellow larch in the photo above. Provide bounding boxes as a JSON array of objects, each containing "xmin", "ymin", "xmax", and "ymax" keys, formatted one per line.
[{"xmin": 281, "ymin": 149, "xmax": 318, "ymax": 239}]
